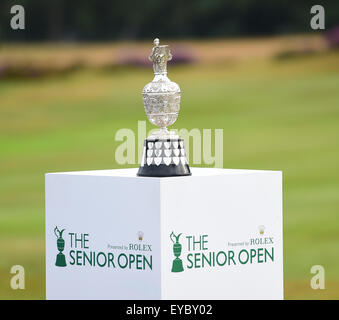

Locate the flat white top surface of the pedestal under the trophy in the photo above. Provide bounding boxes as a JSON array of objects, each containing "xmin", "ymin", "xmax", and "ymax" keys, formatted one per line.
[{"xmin": 46, "ymin": 167, "xmax": 282, "ymax": 179}]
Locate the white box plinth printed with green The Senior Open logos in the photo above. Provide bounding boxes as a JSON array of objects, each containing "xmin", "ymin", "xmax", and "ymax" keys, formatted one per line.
[{"xmin": 46, "ymin": 168, "xmax": 283, "ymax": 299}]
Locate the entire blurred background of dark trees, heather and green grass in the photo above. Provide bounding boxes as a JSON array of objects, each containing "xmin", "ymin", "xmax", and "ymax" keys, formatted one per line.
[{"xmin": 0, "ymin": 0, "xmax": 339, "ymax": 299}]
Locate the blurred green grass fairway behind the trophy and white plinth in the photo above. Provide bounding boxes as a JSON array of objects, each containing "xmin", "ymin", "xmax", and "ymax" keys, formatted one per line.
[{"xmin": 0, "ymin": 38, "xmax": 339, "ymax": 299}]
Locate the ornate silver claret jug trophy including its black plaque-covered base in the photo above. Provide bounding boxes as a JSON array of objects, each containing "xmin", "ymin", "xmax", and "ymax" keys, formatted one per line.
[{"xmin": 138, "ymin": 39, "xmax": 191, "ymax": 177}]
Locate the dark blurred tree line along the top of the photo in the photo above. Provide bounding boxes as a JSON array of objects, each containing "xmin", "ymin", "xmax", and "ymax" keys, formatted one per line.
[{"xmin": 0, "ymin": 0, "xmax": 339, "ymax": 41}]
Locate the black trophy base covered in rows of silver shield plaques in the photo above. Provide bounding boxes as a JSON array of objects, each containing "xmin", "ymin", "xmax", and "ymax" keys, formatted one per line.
[{"xmin": 137, "ymin": 139, "xmax": 191, "ymax": 177}]
